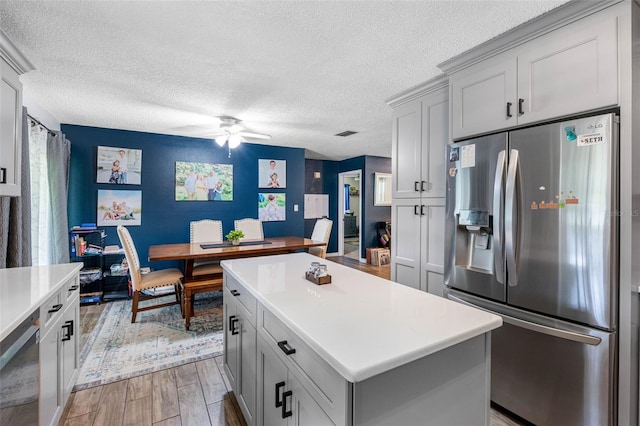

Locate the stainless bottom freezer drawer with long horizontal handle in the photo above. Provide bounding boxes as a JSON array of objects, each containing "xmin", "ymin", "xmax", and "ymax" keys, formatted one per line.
[{"xmin": 447, "ymin": 292, "xmax": 617, "ymax": 426}]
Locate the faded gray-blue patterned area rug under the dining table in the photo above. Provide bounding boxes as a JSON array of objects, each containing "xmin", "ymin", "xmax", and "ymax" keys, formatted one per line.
[{"xmin": 74, "ymin": 292, "xmax": 223, "ymax": 390}]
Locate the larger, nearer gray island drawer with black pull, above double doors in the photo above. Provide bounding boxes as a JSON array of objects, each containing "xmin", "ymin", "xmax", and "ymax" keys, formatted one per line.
[{"xmin": 258, "ymin": 305, "xmax": 349, "ymax": 424}]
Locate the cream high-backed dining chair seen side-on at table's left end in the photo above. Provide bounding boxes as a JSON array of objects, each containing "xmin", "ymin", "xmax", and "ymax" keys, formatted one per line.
[{"xmin": 118, "ymin": 225, "xmax": 183, "ymax": 323}]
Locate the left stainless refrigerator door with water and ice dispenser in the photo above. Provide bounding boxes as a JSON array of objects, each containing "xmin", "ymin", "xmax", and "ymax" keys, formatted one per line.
[{"xmin": 445, "ymin": 133, "xmax": 507, "ymax": 302}]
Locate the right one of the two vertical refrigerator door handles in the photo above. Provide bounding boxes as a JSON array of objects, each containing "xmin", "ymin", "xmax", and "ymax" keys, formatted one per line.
[{"xmin": 504, "ymin": 149, "xmax": 520, "ymax": 287}]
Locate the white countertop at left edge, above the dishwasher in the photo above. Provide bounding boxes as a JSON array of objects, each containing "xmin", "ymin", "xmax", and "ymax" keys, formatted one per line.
[{"xmin": 0, "ymin": 263, "xmax": 82, "ymax": 340}]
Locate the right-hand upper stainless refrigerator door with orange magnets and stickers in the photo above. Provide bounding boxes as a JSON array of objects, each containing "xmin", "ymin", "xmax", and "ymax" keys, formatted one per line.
[{"xmin": 505, "ymin": 114, "xmax": 618, "ymax": 329}]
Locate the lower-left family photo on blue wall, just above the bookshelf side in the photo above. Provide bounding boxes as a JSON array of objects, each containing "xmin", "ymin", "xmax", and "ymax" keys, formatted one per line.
[{"xmin": 97, "ymin": 189, "xmax": 142, "ymax": 226}]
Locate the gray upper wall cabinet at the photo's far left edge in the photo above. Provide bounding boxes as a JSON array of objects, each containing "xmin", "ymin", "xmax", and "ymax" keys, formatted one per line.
[{"xmin": 0, "ymin": 31, "xmax": 33, "ymax": 197}]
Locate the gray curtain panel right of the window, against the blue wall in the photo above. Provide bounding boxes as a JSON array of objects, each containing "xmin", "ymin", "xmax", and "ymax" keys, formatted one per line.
[{"xmin": 47, "ymin": 132, "xmax": 71, "ymax": 264}]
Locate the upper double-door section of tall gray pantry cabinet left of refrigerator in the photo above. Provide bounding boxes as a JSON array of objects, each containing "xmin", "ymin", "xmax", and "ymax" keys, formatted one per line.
[{"xmin": 387, "ymin": 78, "xmax": 449, "ymax": 199}]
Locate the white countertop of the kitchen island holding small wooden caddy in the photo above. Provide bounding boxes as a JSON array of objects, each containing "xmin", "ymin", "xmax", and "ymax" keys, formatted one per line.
[{"xmin": 222, "ymin": 253, "xmax": 502, "ymax": 383}]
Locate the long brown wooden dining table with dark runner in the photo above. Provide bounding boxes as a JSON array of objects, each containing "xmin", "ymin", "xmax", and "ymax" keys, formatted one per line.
[{"xmin": 149, "ymin": 237, "xmax": 326, "ymax": 330}]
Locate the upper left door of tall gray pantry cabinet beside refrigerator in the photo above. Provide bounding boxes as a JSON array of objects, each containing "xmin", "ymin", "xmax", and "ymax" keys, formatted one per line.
[{"xmin": 391, "ymin": 99, "xmax": 422, "ymax": 198}]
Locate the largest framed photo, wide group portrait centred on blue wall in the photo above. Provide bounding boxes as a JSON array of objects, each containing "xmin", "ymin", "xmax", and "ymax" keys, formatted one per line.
[{"xmin": 176, "ymin": 161, "xmax": 233, "ymax": 201}]
